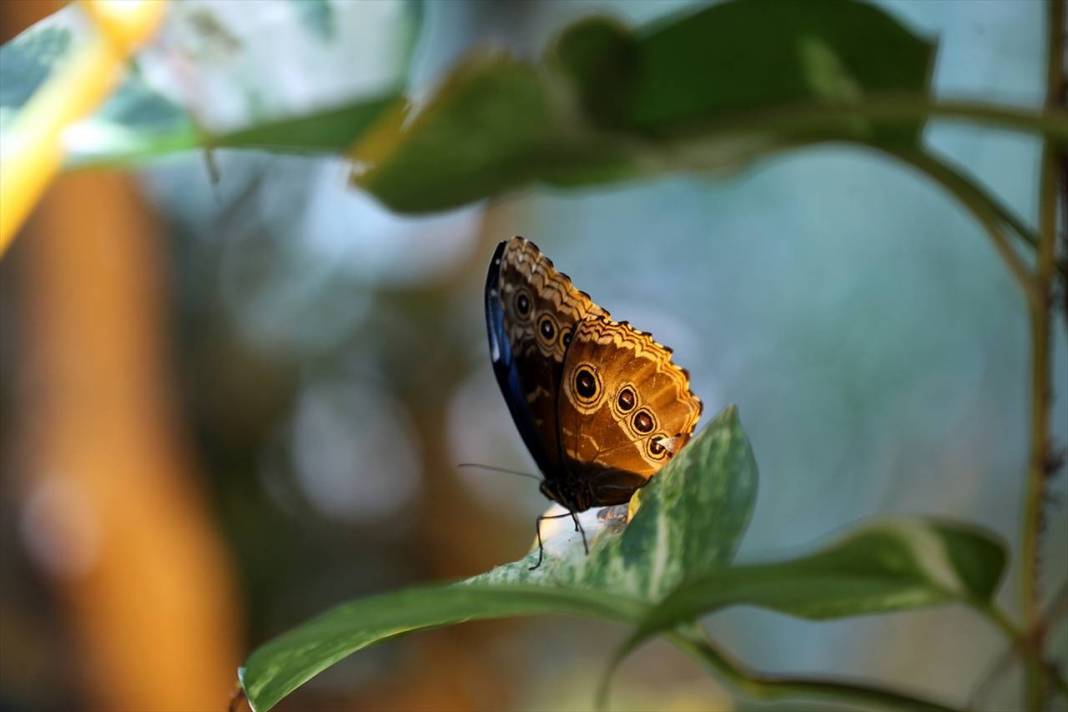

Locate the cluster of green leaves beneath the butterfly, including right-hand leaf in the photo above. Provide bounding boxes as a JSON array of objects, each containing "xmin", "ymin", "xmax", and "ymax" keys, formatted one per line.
[{"xmin": 241, "ymin": 407, "xmax": 1005, "ymax": 711}]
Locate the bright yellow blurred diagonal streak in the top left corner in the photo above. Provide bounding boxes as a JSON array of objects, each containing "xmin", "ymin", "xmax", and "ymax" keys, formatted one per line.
[{"xmin": 0, "ymin": 0, "xmax": 167, "ymax": 255}]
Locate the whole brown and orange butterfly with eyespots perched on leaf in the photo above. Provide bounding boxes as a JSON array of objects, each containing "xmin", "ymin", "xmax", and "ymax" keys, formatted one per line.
[{"xmin": 485, "ymin": 237, "xmax": 702, "ymax": 568}]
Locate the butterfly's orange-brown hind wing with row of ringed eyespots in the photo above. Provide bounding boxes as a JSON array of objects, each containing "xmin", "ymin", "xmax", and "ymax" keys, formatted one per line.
[{"xmin": 559, "ymin": 315, "xmax": 702, "ymax": 505}]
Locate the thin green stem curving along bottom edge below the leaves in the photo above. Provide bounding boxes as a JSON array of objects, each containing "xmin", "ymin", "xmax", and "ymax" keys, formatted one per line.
[{"xmin": 668, "ymin": 629, "xmax": 957, "ymax": 712}]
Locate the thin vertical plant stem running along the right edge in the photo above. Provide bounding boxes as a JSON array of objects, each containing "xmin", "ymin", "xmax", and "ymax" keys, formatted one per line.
[{"xmin": 1020, "ymin": 0, "xmax": 1065, "ymax": 712}]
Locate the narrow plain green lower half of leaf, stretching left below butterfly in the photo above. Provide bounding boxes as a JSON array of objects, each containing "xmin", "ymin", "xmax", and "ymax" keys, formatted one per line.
[{"xmin": 239, "ymin": 585, "xmax": 645, "ymax": 712}]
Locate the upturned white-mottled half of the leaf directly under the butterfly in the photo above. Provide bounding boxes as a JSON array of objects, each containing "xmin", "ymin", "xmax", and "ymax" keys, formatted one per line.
[{"xmin": 472, "ymin": 406, "xmax": 757, "ymax": 601}]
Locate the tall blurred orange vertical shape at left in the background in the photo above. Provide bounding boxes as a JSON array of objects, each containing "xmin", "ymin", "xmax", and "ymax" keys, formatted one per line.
[{"xmin": 19, "ymin": 167, "xmax": 240, "ymax": 711}]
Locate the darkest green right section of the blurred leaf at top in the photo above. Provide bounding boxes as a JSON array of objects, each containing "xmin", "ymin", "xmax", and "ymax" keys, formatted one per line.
[{"xmin": 627, "ymin": 0, "xmax": 935, "ymax": 143}]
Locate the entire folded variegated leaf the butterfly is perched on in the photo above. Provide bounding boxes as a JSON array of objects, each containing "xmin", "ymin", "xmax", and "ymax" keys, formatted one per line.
[{"xmin": 240, "ymin": 407, "xmax": 756, "ymax": 712}]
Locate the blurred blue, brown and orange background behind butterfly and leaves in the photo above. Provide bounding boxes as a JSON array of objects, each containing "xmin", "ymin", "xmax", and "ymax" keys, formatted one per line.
[{"xmin": 0, "ymin": 0, "xmax": 1068, "ymax": 711}]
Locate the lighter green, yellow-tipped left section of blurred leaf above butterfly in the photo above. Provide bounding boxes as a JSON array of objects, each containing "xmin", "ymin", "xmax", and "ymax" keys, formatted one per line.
[{"xmin": 351, "ymin": 54, "xmax": 631, "ymax": 212}]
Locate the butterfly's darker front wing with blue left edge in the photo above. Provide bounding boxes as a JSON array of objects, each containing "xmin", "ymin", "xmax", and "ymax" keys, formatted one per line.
[{"xmin": 486, "ymin": 237, "xmax": 609, "ymax": 478}]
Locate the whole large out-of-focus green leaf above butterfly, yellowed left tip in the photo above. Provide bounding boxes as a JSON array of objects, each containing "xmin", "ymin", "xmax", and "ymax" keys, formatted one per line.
[{"xmin": 352, "ymin": 0, "xmax": 935, "ymax": 212}]
